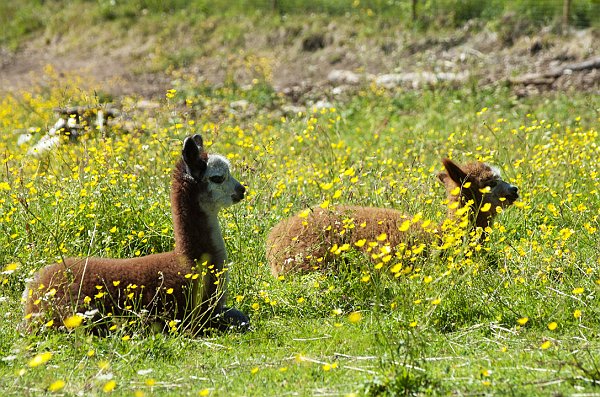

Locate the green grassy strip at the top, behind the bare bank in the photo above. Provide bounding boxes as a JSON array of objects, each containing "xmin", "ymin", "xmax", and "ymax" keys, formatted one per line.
[{"xmin": 0, "ymin": 0, "xmax": 600, "ymax": 51}]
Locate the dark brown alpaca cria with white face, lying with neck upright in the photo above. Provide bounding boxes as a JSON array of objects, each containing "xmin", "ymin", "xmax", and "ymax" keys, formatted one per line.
[{"xmin": 23, "ymin": 135, "xmax": 249, "ymax": 332}]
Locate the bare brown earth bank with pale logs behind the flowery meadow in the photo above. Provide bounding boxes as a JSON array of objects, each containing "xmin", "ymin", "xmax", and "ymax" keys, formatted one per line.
[{"xmin": 0, "ymin": 20, "xmax": 600, "ymax": 99}]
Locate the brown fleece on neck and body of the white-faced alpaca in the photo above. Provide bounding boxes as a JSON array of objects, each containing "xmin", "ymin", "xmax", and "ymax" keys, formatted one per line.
[{"xmin": 25, "ymin": 156, "xmax": 223, "ymax": 330}]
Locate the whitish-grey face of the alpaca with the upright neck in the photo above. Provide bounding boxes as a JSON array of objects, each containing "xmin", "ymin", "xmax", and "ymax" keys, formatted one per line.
[{"xmin": 199, "ymin": 154, "xmax": 246, "ymax": 211}]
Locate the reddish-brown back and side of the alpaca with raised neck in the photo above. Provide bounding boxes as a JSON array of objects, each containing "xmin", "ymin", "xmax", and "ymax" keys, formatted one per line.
[{"xmin": 23, "ymin": 252, "xmax": 192, "ymax": 326}]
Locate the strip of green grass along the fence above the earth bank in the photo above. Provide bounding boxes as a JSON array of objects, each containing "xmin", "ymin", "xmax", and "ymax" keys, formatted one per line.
[{"xmin": 0, "ymin": 0, "xmax": 600, "ymax": 51}]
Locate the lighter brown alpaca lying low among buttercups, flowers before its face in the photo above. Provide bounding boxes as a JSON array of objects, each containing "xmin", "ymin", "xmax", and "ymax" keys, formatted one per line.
[{"xmin": 267, "ymin": 159, "xmax": 519, "ymax": 277}]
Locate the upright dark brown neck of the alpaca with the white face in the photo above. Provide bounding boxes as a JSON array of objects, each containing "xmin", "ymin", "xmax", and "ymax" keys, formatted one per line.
[{"xmin": 171, "ymin": 162, "xmax": 227, "ymax": 268}]
